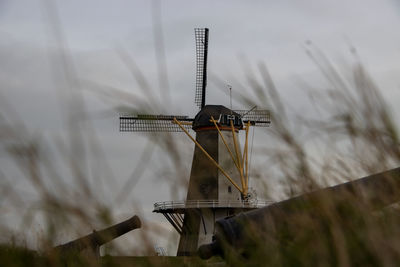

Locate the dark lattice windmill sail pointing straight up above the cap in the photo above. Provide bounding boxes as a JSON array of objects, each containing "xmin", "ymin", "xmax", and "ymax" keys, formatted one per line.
[{"xmin": 194, "ymin": 28, "xmax": 208, "ymax": 109}]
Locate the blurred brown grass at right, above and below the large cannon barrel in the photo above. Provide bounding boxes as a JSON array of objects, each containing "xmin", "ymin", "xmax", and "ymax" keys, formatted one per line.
[{"xmin": 214, "ymin": 47, "xmax": 400, "ymax": 266}]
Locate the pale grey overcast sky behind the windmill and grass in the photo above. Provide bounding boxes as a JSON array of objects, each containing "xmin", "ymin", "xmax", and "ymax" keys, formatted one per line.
[{"xmin": 0, "ymin": 0, "xmax": 400, "ymax": 254}]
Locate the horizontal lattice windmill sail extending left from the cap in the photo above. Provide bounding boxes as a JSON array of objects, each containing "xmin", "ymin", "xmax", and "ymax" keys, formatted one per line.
[{"xmin": 119, "ymin": 114, "xmax": 193, "ymax": 132}]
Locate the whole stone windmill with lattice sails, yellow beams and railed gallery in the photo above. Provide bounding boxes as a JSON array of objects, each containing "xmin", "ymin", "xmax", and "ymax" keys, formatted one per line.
[{"xmin": 120, "ymin": 28, "xmax": 270, "ymax": 256}]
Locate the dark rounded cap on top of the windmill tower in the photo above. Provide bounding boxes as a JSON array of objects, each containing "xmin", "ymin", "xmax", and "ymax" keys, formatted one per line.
[{"xmin": 193, "ymin": 105, "xmax": 243, "ymax": 131}]
